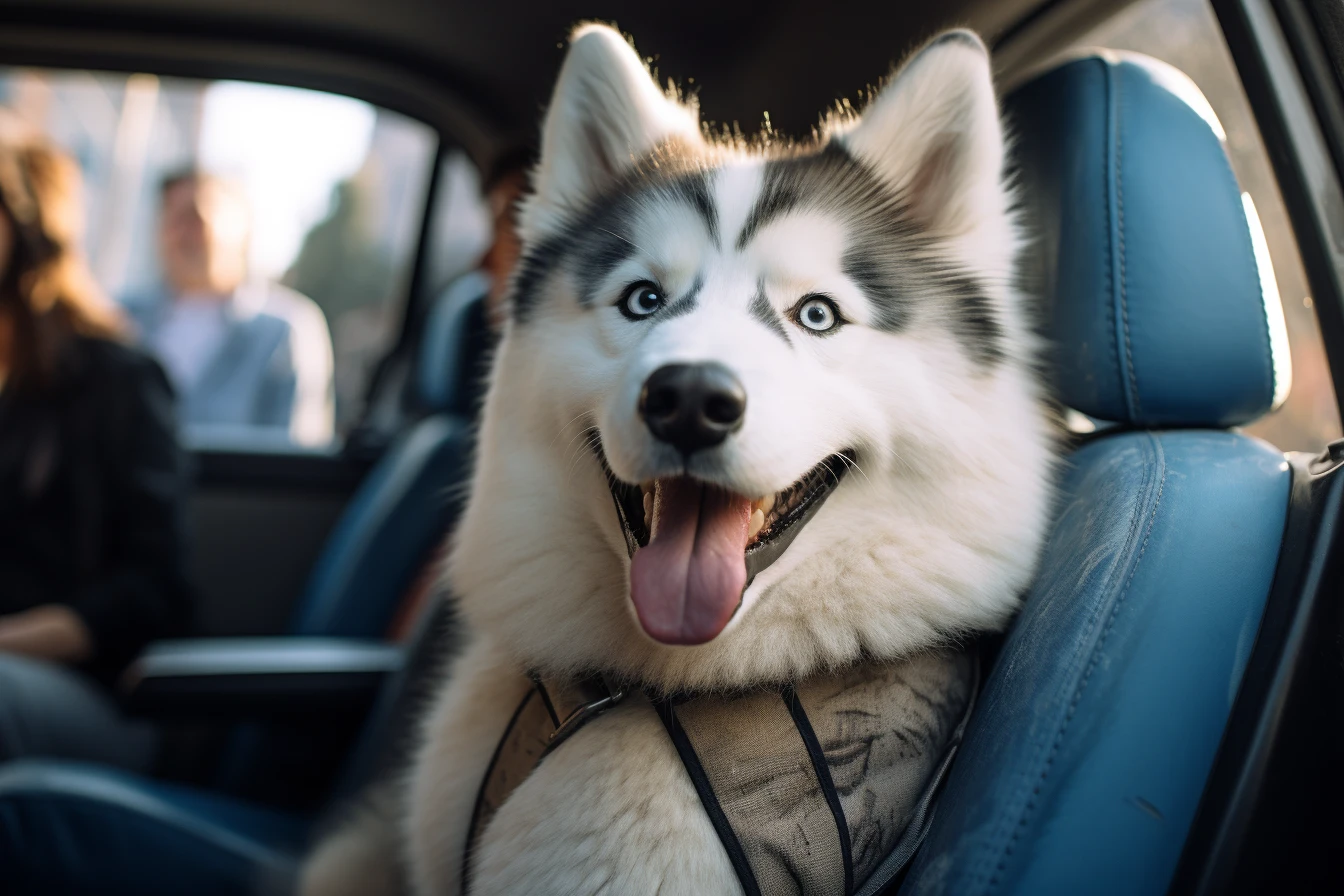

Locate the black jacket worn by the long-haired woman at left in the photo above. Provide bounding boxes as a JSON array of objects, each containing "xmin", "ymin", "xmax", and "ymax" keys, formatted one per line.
[{"xmin": 0, "ymin": 339, "xmax": 191, "ymax": 681}]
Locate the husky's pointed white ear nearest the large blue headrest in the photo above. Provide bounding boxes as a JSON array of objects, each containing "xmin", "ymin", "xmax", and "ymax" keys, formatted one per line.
[{"xmin": 839, "ymin": 31, "xmax": 1004, "ymax": 232}]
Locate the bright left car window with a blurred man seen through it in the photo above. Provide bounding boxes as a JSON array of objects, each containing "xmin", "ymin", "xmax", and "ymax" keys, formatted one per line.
[{"xmin": 0, "ymin": 69, "xmax": 438, "ymax": 450}]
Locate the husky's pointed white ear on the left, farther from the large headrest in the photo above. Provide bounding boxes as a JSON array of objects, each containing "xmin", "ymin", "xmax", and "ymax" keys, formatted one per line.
[{"xmin": 524, "ymin": 24, "xmax": 703, "ymax": 236}]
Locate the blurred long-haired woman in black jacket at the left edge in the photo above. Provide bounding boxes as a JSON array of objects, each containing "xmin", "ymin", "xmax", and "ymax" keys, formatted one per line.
[{"xmin": 0, "ymin": 110, "xmax": 190, "ymax": 770}]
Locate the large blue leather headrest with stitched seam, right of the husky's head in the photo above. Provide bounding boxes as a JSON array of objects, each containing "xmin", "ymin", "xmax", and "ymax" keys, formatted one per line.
[{"xmin": 1004, "ymin": 51, "xmax": 1292, "ymax": 427}]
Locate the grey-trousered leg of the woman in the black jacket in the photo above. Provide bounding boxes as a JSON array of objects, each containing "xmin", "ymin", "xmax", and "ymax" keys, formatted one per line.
[{"xmin": 0, "ymin": 653, "xmax": 159, "ymax": 772}]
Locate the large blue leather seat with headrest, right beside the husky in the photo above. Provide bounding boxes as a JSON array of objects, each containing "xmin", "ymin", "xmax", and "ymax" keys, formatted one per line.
[{"xmin": 902, "ymin": 54, "xmax": 1290, "ymax": 896}]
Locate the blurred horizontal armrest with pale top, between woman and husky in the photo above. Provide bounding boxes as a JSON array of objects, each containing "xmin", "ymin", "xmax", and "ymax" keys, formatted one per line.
[{"xmin": 121, "ymin": 638, "xmax": 405, "ymax": 720}]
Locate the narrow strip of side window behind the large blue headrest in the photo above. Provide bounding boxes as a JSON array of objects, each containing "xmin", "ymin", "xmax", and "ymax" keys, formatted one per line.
[{"xmin": 1053, "ymin": 0, "xmax": 1340, "ymax": 451}]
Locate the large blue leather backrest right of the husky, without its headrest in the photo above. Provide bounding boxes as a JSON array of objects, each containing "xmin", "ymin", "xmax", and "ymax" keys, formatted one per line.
[{"xmin": 902, "ymin": 431, "xmax": 1290, "ymax": 896}]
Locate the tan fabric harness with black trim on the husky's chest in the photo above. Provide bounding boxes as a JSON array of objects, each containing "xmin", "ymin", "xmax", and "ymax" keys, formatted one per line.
[{"xmin": 462, "ymin": 649, "xmax": 978, "ymax": 896}]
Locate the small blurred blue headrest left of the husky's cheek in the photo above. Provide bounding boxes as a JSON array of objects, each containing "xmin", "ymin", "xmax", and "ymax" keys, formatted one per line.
[{"xmin": 415, "ymin": 271, "xmax": 492, "ymax": 416}]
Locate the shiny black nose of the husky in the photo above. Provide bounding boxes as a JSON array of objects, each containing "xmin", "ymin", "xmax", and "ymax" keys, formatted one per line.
[{"xmin": 640, "ymin": 364, "xmax": 747, "ymax": 454}]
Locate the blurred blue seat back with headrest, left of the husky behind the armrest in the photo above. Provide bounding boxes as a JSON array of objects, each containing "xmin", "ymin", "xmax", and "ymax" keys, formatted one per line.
[{"xmin": 211, "ymin": 274, "xmax": 491, "ymax": 806}]
